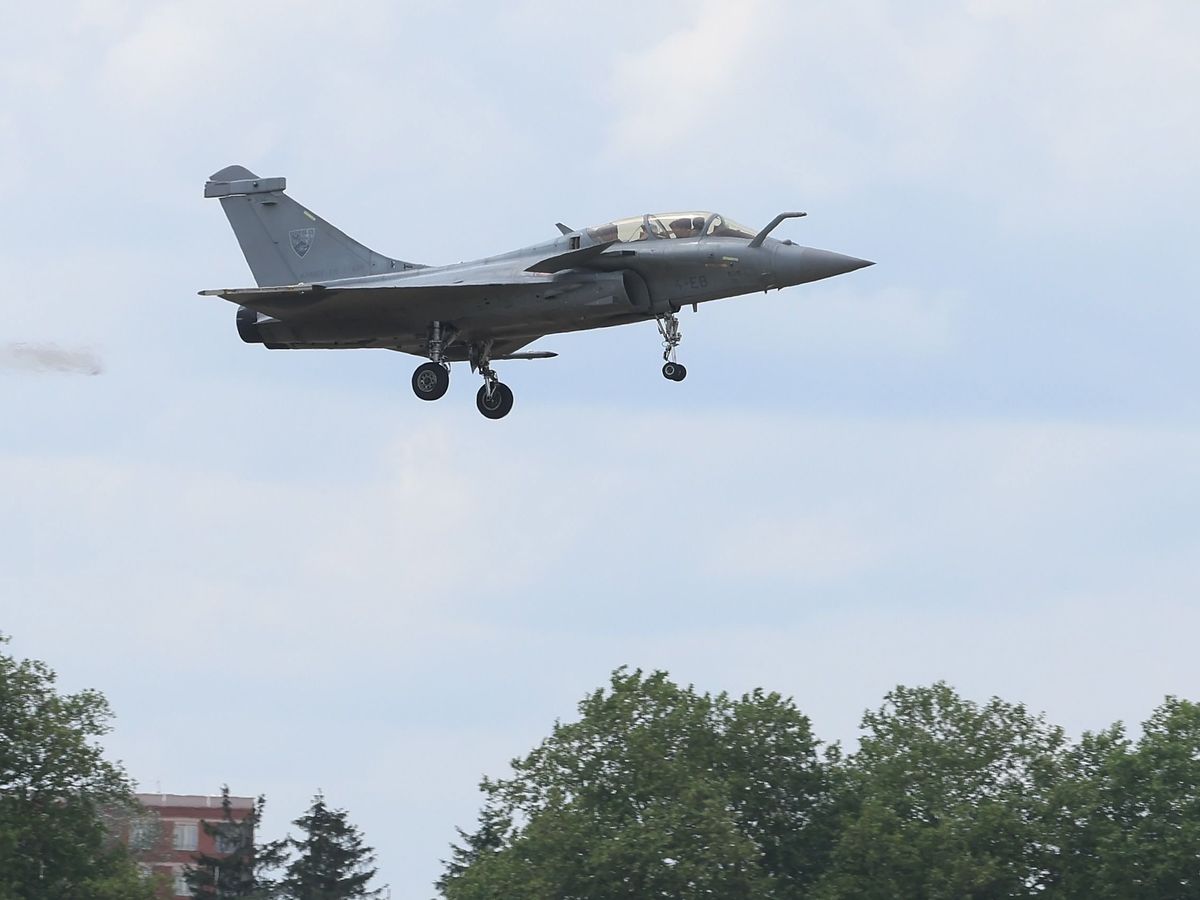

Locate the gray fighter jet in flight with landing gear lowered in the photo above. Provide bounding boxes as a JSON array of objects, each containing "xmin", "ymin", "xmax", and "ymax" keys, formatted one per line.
[{"xmin": 200, "ymin": 166, "xmax": 871, "ymax": 419}]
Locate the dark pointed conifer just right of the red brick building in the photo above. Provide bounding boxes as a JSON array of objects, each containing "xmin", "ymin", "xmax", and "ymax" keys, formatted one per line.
[{"xmin": 276, "ymin": 792, "xmax": 383, "ymax": 900}]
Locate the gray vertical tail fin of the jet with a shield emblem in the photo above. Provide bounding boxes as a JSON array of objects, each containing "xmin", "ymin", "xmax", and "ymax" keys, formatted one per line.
[{"xmin": 204, "ymin": 166, "xmax": 424, "ymax": 287}]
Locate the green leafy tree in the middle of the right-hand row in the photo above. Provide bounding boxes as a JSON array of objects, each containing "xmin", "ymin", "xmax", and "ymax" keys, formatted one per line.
[{"xmin": 816, "ymin": 683, "xmax": 1066, "ymax": 900}]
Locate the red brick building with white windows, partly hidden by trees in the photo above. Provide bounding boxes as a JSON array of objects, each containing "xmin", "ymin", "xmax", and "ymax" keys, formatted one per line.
[{"xmin": 128, "ymin": 793, "xmax": 254, "ymax": 898}]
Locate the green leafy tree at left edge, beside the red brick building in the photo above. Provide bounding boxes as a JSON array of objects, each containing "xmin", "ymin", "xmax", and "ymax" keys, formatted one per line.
[{"xmin": 0, "ymin": 635, "xmax": 154, "ymax": 900}]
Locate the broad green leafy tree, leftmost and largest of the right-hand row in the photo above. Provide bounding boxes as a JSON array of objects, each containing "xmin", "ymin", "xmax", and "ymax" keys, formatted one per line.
[{"xmin": 438, "ymin": 670, "xmax": 830, "ymax": 900}]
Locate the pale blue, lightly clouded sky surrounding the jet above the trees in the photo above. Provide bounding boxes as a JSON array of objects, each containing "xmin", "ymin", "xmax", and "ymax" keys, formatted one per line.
[{"xmin": 0, "ymin": 0, "xmax": 1200, "ymax": 900}]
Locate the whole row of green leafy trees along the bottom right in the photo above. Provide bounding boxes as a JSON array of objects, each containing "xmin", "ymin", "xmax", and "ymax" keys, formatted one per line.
[{"xmin": 438, "ymin": 670, "xmax": 1200, "ymax": 900}]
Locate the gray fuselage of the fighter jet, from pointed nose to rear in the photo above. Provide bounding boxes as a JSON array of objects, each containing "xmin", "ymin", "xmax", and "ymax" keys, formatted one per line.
[{"xmin": 246, "ymin": 217, "xmax": 870, "ymax": 355}]
